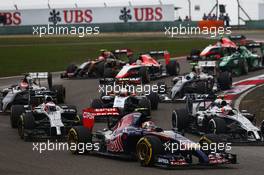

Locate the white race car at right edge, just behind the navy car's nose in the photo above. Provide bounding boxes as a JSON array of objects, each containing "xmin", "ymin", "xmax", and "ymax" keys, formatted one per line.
[{"xmin": 172, "ymin": 95, "xmax": 264, "ymax": 144}]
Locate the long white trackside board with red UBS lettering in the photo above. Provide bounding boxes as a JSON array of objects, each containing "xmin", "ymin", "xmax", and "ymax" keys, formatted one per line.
[{"xmin": 0, "ymin": 5, "xmax": 174, "ymax": 26}]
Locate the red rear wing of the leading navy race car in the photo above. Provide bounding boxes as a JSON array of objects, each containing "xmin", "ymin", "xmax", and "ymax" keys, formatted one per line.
[{"xmin": 82, "ymin": 108, "xmax": 120, "ymax": 131}]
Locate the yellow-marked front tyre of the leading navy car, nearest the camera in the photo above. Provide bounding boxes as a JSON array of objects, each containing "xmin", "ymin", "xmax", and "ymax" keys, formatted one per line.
[{"xmin": 136, "ymin": 136, "xmax": 163, "ymax": 167}]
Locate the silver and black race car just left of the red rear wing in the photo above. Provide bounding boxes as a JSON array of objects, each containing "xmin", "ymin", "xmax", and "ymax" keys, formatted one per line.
[{"xmin": 14, "ymin": 96, "xmax": 82, "ymax": 141}]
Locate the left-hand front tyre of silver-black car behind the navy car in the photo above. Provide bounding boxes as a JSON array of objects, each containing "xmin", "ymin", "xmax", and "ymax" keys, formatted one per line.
[{"xmin": 17, "ymin": 112, "xmax": 35, "ymax": 141}]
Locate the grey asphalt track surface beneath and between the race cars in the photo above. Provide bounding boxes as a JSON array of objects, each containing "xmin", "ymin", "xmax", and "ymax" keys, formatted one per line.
[{"xmin": 0, "ymin": 37, "xmax": 264, "ymax": 175}]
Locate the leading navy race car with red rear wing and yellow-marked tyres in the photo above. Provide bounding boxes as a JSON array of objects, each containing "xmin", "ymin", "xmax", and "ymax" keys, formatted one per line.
[{"xmin": 68, "ymin": 108, "xmax": 236, "ymax": 168}]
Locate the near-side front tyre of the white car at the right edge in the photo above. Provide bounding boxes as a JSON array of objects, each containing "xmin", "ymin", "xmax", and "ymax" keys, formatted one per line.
[{"xmin": 208, "ymin": 118, "xmax": 226, "ymax": 134}]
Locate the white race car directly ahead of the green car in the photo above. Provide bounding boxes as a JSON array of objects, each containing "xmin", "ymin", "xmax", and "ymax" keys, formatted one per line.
[{"xmin": 158, "ymin": 66, "xmax": 232, "ymax": 102}]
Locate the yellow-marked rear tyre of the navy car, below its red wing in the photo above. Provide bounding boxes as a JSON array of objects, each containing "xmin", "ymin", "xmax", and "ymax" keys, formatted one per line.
[{"xmin": 68, "ymin": 126, "xmax": 92, "ymax": 154}]
